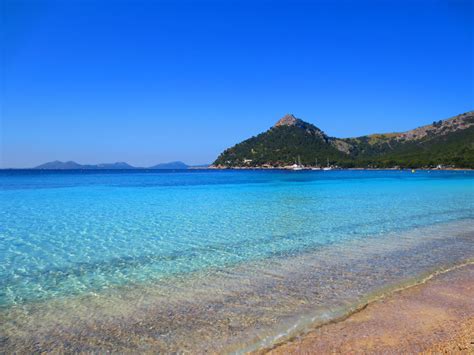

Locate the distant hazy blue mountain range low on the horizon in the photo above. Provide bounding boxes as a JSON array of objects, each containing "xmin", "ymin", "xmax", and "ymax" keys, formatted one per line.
[{"xmin": 34, "ymin": 160, "xmax": 207, "ymax": 170}]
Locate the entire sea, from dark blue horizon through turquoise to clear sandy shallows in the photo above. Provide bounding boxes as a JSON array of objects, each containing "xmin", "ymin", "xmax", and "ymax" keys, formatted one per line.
[{"xmin": 0, "ymin": 171, "xmax": 474, "ymax": 351}]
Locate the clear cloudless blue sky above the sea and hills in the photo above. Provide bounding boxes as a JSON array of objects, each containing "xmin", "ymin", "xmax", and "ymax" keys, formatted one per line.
[{"xmin": 0, "ymin": 0, "xmax": 474, "ymax": 168}]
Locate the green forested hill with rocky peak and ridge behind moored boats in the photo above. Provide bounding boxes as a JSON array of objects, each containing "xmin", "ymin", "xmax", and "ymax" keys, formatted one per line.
[{"xmin": 213, "ymin": 111, "xmax": 474, "ymax": 168}]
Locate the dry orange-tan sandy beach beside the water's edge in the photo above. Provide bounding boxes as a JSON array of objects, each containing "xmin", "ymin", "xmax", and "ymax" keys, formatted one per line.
[{"xmin": 262, "ymin": 264, "xmax": 474, "ymax": 354}]
